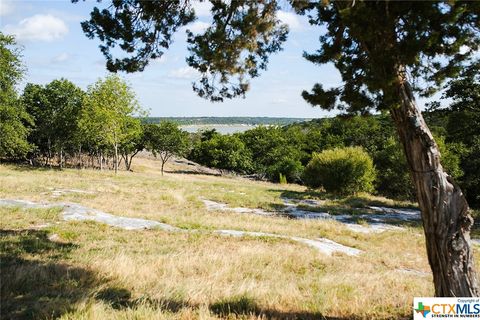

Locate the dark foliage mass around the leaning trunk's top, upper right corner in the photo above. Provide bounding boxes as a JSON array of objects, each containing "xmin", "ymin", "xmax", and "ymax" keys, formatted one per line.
[{"xmin": 295, "ymin": 1, "xmax": 480, "ymax": 113}]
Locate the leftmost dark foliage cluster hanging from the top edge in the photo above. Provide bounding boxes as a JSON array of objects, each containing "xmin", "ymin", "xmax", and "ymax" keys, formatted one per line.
[{"xmin": 77, "ymin": 0, "xmax": 195, "ymax": 72}]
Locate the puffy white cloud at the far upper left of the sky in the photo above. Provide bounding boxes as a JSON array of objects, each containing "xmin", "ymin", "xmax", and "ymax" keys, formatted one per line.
[{"xmin": 5, "ymin": 14, "xmax": 68, "ymax": 42}]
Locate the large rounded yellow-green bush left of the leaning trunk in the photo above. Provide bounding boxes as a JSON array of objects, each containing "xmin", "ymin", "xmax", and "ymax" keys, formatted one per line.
[{"xmin": 304, "ymin": 147, "xmax": 375, "ymax": 194}]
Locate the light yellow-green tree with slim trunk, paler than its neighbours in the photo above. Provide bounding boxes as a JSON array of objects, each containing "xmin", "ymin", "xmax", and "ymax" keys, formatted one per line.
[{"xmin": 80, "ymin": 75, "xmax": 142, "ymax": 173}]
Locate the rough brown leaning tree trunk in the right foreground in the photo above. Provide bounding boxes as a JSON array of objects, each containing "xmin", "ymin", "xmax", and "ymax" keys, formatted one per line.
[{"xmin": 391, "ymin": 79, "xmax": 480, "ymax": 297}]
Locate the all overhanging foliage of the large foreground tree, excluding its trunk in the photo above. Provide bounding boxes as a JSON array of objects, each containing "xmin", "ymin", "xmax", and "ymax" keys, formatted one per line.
[{"xmin": 78, "ymin": 0, "xmax": 480, "ymax": 107}]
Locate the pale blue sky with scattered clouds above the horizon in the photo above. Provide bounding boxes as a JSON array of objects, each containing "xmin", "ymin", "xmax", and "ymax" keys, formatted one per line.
[{"xmin": 0, "ymin": 0, "xmax": 432, "ymax": 118}]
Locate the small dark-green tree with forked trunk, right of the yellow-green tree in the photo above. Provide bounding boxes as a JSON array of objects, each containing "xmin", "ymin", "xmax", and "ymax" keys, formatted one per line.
[{"xmin": 145, "ymin": 121, "xmax": 189, "ymax": 176}]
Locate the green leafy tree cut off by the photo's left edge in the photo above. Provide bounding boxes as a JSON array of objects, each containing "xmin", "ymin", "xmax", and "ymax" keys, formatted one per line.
[{"xmin": 0, "ymin": 32, "xmax": 31, "ymax": 158}]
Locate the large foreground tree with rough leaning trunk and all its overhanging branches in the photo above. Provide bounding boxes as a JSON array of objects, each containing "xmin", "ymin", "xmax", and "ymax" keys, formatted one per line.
[{"xmin": 75, "ymin": 0, "xmax": 480, "ymax": 296}]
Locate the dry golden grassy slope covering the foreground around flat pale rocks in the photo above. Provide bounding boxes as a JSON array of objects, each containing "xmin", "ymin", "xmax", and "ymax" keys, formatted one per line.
[{"xmin": 0, "ymin": 159, "xmax": 464, "ymax": 319}]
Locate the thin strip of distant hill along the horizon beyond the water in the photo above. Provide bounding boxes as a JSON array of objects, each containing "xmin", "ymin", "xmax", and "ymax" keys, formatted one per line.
[{"xmin": 143, "ymin": 117, "xmax": 312, "ymax": 125}]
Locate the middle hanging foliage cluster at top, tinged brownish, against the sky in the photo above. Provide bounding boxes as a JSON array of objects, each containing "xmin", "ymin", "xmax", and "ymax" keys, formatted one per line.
[{"xmin": 187, "ymin": 0, "xmax": 288, "ymax": 101}]
